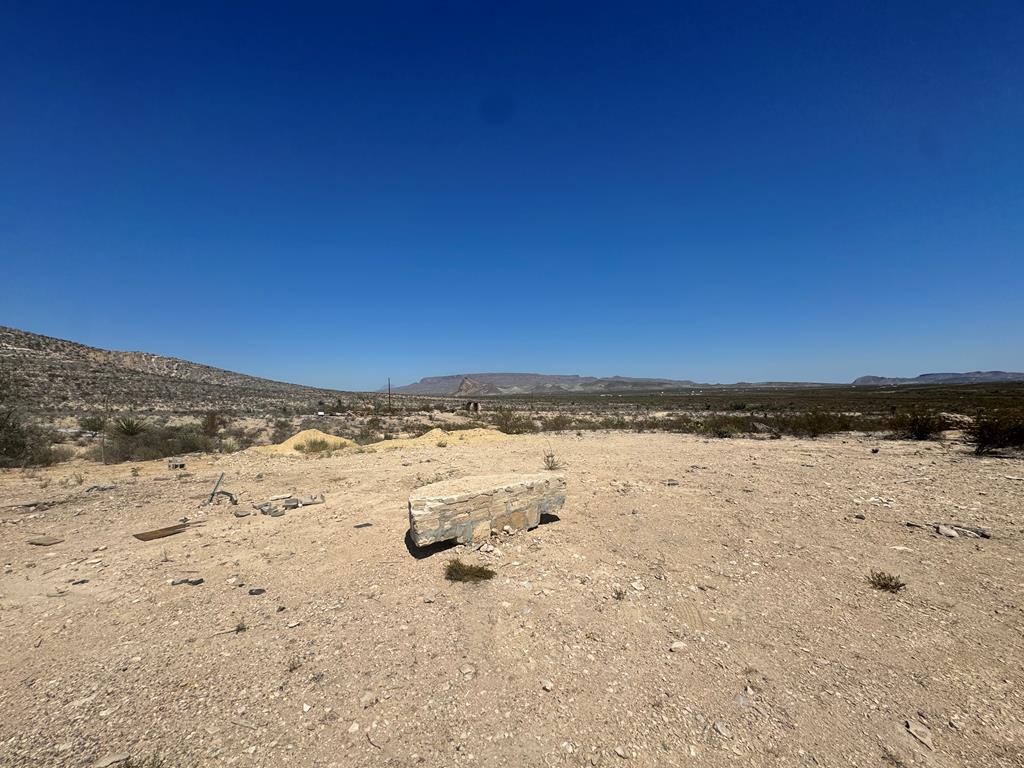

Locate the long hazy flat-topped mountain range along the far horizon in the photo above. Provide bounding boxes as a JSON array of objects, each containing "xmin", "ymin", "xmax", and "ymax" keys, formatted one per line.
[{"xmin": 392, "ymin": 371, "xmax": 1024, "ymax": 397}]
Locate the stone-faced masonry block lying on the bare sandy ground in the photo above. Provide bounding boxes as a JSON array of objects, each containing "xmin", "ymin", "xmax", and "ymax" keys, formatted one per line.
[{"xmin": 409, "ymin": 473, "xmax": 565, "ymax": 547}]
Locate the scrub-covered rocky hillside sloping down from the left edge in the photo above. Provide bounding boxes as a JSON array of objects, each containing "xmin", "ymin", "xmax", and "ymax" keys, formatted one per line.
[{"xmin": 0, "ymin": 326, "xmax": 354, "ymax": 413}]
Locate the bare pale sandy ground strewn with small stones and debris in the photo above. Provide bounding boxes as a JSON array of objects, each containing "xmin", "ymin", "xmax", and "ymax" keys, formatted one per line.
[{"xmin": 0, "ymin": 433, "xmax": 1024, "ymax": 768}]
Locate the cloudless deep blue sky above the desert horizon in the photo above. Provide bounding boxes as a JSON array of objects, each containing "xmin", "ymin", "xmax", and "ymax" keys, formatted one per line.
[{"xmin": 0, "ymin": 0, "xmax": 1024, "ymax": 389}]
